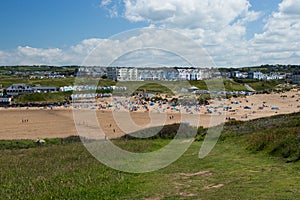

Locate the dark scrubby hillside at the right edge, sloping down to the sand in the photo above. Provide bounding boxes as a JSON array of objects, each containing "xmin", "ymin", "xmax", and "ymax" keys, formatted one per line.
[{"xmin": 222, "ymin": 113, "xmax": 300, "ymax": 162}]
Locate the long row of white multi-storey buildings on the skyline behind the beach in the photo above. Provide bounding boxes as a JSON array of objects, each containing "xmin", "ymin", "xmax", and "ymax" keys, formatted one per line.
[{"xmin": 107, "ymin": 67, "xmax": 212, "ymax": 81}]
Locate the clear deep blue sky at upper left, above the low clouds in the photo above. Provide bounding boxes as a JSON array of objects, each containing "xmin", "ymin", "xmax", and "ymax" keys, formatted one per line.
[{"xmin": 0, "ymin": 0, "xmax": 143, "ymax": 49}]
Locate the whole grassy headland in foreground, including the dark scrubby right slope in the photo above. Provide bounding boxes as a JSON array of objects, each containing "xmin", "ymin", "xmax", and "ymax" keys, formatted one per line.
[{"xmin": 0, "ymin": 113, "xmax": 300, "ymax": 199}]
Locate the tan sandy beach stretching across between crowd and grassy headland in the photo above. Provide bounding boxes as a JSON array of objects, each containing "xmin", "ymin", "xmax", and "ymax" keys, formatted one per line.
[{"xmin": 0, "ymin": 91, "xmax": 300, "ymax": 140}]
